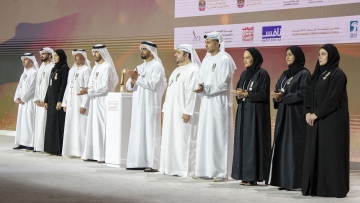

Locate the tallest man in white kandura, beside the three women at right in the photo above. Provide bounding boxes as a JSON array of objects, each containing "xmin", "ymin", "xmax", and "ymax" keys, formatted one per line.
[{"xmin": 195, "ymin": 32, "xmax": 236, "ymax": 182}]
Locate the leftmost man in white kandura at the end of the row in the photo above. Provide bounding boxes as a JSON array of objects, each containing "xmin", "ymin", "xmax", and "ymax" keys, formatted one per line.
[{"xmin": 13, "ymin": 53, "xmax": 39, "ymax": 151}]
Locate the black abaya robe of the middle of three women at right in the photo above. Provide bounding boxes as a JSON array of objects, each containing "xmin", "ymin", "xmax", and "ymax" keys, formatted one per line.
[{"xmin": 269, "ymin": 69, "xmax": 310, "ymax": 189}]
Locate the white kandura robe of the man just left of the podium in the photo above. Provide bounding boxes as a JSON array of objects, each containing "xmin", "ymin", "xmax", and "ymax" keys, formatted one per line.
[{"xmin": 82, "ymin": 61, "xmax": 111, "ymax": 161}]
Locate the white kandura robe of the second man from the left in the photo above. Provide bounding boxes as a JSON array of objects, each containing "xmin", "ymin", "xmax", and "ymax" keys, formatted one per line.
[{"xmin": 34, "ymin": 62, "xmax": 55, "ymax": 151}]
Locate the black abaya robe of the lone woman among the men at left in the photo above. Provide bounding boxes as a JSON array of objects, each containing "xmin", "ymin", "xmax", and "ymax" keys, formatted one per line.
[{"xmin": 44, "ymin": 64, "xmax": 69, "ymax": 155}]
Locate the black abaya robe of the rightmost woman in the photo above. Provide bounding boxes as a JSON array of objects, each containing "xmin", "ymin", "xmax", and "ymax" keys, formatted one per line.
[{"xmin": 302, "ymin": 67, "xmax": 350, "ymax": 197}]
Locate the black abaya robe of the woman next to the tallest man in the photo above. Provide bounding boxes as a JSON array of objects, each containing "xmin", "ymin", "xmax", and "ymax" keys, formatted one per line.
[{"xmin": 231, "ymin": 68, "xmax": 271, "ymax": 183}]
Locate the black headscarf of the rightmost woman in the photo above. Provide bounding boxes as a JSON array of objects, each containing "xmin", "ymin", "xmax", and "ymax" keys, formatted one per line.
[{"xmin": 305, "ymin": 44, "xmax": 340, "ymax": 107}]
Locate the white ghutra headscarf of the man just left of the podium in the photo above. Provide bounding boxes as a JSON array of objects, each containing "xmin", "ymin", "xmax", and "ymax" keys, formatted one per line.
[{"xmin": 91, "ymin": 44, "xmax": 119, "ymax": 92}]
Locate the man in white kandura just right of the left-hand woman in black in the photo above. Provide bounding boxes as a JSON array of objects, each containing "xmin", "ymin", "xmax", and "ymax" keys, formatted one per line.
[{"xmin": 61, "ymin": 49, "xmax": 91, "ymax": 157}]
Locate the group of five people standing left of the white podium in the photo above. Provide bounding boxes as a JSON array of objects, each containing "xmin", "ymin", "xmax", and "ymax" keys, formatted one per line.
[{"xmin": 14, "ymin": 44, "xmax": 118, "ymax": 163}]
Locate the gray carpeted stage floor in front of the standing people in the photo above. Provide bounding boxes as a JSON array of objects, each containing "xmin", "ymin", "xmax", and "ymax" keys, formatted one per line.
[{"xmin": 0, "ymin": 136, "xmax": 360, "ymax": 203}]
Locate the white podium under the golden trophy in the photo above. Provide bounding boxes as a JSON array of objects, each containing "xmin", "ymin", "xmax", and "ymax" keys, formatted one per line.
[{"xmin": 105, "ymin": 92, "xmax": 132, "ymax": 168}]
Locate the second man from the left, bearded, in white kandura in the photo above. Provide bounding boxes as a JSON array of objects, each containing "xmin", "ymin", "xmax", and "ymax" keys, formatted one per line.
[{"xmin": 34, "ymin": 47, "xmax": 55, "ymax": 152}]
